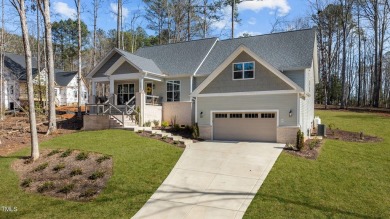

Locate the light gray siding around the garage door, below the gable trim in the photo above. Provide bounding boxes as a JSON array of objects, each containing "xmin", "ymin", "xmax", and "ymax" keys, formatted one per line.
[{"xmin": 196, "ymin": 94, "xmax": 298, "ymax": 127}]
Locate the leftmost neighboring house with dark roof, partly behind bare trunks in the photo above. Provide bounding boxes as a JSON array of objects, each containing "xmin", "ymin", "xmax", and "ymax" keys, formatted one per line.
[{"xmin": 3, "ymin": 53, "xmax": 47, "ymax": 110}]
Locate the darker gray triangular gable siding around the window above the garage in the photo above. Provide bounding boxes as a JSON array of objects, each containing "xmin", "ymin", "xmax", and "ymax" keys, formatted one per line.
[{"xmin": 201, "ymin": 52, "xmax": 292, "ymax": 93}]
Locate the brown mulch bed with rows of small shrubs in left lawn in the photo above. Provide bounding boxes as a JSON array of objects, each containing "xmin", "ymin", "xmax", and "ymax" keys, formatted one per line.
[{"xmin": 11, "ymin": 149, "xmax": 113, "ymax": 201}]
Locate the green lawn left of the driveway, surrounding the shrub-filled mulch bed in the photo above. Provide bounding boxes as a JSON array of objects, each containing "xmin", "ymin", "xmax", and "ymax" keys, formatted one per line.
[{"xmin": 0, "ymin": 130, "xmax": 183, "ymax": 219}]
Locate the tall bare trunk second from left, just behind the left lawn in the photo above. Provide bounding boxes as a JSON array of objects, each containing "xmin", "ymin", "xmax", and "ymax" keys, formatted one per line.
[{"xmin": 38, "ymin": 0, "xmax": 57, "ymax": 134}]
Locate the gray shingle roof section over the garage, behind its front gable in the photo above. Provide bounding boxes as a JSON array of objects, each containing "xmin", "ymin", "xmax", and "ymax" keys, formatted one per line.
[{"xmin": 197, "ymin": 28, "xmax": 316, "ymax": 75}]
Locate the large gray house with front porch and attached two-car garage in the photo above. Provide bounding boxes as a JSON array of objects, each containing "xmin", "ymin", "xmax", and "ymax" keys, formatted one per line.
[{"xmin": 84, "ymin": 28, "xmax": 318, "ymax": 143}]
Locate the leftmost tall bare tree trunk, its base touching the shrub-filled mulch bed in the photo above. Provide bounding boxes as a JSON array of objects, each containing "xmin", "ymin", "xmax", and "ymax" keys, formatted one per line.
[{"xmin": 10, "ymin": 0, "xmax": 39, "ymax": 161}]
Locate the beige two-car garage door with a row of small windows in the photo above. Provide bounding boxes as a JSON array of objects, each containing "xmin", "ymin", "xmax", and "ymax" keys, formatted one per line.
[{"xmin": 213, "ymin": 112, "xmax": 277, "ymax": 142}]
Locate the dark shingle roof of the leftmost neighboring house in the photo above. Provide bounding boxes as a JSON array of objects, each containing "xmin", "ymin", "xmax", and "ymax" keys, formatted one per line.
[{"xmin": 4, "ymin": 53, "xmax": 38, "ymax": 81}]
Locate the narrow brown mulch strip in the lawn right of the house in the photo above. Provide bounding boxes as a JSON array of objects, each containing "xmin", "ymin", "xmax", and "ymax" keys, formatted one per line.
[{"xmin": 326, "ymin": 128, "xmax": 383, "ymax": 142}]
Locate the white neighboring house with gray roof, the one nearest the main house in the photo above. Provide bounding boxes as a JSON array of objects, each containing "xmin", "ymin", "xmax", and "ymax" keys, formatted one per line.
[{"xmin": 55, "ymin": 70, "xmax": 88, "ymax": 106}]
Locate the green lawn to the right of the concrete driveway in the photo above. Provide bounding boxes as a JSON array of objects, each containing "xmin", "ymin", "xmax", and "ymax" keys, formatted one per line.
[{"xmin": 245, "ymin": 111, "xmax": 390, "ymax": 218}]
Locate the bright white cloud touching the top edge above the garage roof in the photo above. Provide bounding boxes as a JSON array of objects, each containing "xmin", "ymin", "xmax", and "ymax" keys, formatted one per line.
[{"xmin": 237, "ymin": 0, "xmax": 291, "ymax": 16}]
